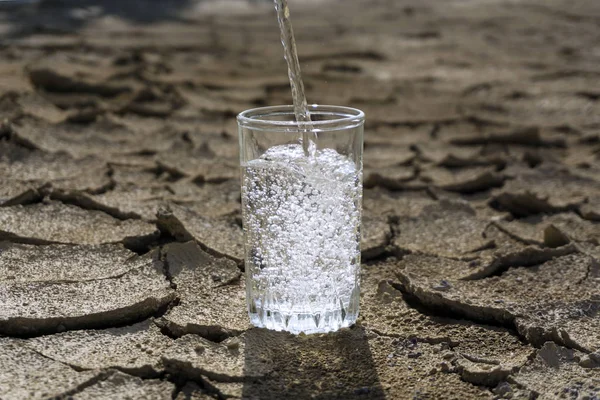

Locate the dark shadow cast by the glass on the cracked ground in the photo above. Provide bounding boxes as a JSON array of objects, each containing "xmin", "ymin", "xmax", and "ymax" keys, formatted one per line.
[{"xmin": 242, "ymin": 326, "xmax": 385, "ymax": 400}]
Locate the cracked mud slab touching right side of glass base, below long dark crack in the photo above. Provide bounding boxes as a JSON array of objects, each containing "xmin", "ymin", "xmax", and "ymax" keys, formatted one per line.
[{"xmin": 360, "ymin": 262, "xmax": 533, "ymax": 386}]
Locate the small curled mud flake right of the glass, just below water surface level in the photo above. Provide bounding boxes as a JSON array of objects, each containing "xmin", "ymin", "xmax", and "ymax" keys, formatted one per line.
[{"xmin": 421, "ymin": 167, "xmax": 504, "ymax": 193}]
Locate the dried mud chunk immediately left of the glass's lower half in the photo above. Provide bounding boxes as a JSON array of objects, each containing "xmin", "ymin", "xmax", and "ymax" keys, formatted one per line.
[{"xmin": 161, "ymin": 242, "xmax": 250, "ymax": 340}]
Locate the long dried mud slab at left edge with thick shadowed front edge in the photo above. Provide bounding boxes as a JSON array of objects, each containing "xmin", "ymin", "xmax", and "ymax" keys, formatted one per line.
[{"xmin": 0, "ymin": 253, "xmax": 174, "ymax": 335}]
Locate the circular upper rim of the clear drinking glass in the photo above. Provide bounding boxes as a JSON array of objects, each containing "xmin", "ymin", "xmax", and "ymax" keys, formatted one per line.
[{"xmin": 237, "ymin": 104, "xmax": 365, "ymax": 132}]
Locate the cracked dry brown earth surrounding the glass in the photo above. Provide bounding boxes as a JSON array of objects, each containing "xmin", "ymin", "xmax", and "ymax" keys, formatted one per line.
[{"xmin": 0, "ymin": 0, "xmax": 600, "ymax": 400}]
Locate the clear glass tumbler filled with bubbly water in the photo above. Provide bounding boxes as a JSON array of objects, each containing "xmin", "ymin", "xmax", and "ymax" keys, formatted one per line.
[{"xmin": 237, "ymin": 105, "xmax": 364, "ymax": 334}]
